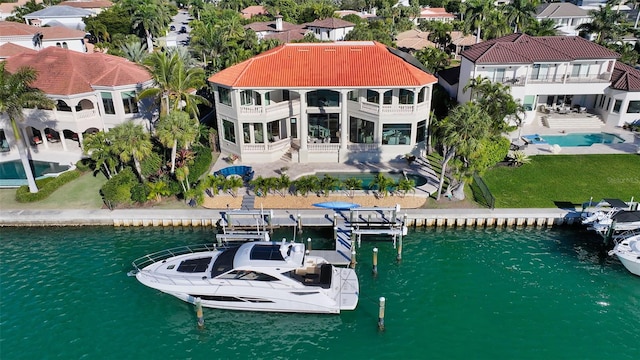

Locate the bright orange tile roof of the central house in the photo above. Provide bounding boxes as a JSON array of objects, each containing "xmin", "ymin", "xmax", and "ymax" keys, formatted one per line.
[{"xmin": 209, "ymin": 41, "xmax": 437, "ymax": 88}]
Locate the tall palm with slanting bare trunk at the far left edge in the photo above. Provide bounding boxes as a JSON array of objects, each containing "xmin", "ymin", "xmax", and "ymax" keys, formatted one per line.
[{"xmin": 0, "ymin": 62, "xmax": 55, "ymax": 193}]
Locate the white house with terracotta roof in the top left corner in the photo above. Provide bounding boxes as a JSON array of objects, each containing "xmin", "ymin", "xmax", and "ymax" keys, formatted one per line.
[{"xmin": 0, "ymin": 21, "xmax": 87, "ymax": 52}]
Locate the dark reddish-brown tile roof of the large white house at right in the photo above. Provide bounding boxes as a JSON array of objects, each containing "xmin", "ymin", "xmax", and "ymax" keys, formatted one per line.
[{"xmin": 460, "ymin": 34, "xmax": 620, "ymax": 64}]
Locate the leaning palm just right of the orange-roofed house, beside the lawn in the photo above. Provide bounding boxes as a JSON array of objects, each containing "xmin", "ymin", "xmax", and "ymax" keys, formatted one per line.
[{"xmin": 436, "ymin": 102, "xmax": 491, "ymax": 200}]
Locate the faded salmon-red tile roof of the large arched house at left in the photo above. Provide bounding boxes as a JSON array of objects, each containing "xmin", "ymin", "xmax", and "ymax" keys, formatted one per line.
[{"xmin": 6, "ymin": 46, "xmax": 151, "ymax": 95}]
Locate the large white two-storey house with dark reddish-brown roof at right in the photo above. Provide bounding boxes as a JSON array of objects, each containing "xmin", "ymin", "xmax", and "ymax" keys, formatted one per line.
[{"xmin": 457, "ymin": 34, "xmax": 638, "ymax": 126}]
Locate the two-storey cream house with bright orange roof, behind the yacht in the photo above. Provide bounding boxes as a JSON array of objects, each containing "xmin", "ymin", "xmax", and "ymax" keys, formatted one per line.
[{"xmin": 209, "ymin": 41, "xmax": 436, "ymax": 163}]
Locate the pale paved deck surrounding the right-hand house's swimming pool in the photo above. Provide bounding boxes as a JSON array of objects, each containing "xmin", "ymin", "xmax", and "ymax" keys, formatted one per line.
[{"xmin": 509, "ymin": 121, "xmax": 640, "ymax": 156}]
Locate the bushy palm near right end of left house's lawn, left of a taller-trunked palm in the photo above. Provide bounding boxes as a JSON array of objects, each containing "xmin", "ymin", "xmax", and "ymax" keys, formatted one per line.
[{"xmin": 109, "ymin": 120, "xmax": 153, "ymax": 182}]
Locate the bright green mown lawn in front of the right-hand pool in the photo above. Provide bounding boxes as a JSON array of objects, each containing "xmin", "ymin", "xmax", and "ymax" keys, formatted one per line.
[{"xmin": 483, "ymin": 155, "xmax": 640, "ymax": 208}]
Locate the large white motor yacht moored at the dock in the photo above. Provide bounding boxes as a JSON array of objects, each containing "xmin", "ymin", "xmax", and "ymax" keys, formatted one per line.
[{"xmin": 133, "ymin": 240, "xmax": 359, "ymax": 314}]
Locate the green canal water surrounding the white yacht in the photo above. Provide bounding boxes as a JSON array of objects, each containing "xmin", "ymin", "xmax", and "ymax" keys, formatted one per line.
[{"xmin": 0, "ymin": 227, "xmax": 640, "ymax": 360}]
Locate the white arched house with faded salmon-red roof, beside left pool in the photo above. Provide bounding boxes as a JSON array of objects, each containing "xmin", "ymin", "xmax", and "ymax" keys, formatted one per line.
[{"xmin": 0, "ymin": 47, "xmax": 153, "ymax": 160}]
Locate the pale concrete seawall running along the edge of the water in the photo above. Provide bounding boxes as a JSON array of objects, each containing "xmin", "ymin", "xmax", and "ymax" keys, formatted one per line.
[{"xmin": 0, "ymin": 208, "xmax": 580, "ymax": 227}]
